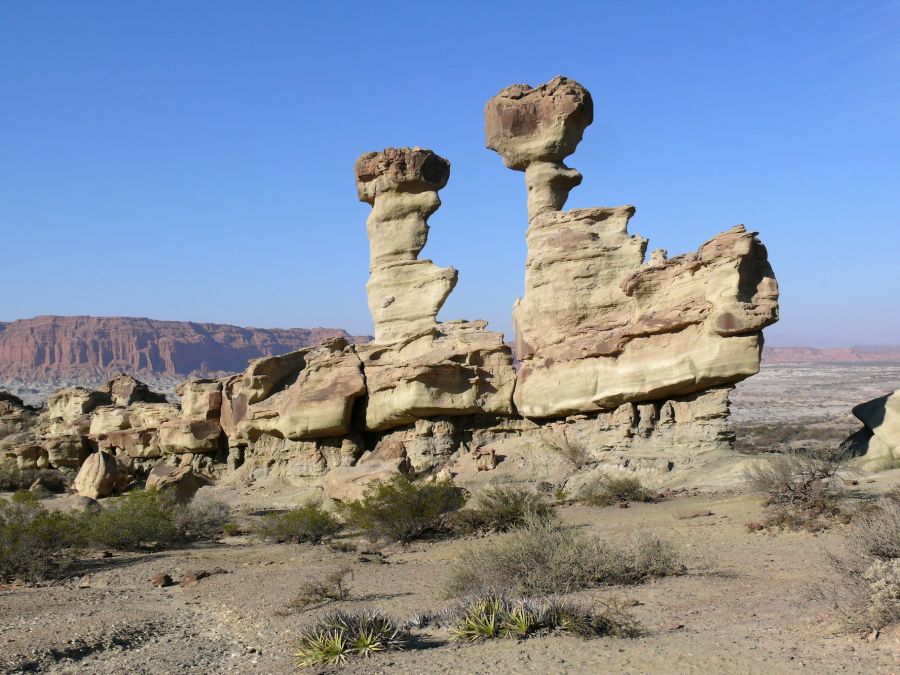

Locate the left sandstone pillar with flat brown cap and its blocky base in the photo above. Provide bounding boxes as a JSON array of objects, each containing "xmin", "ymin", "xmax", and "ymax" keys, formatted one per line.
[{"xmin": 356, "ymin": 148, "xmax": 515, "ymax": 430}]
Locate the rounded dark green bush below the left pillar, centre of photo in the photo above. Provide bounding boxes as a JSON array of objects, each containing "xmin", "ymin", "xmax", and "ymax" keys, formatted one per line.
[{"xmin": 346, "ymin": 474, "xmax": 465, "ymax": 543}]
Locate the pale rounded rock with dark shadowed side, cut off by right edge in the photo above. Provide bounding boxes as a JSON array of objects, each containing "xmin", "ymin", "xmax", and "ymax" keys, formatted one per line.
[{"xmin": 844, "ymin": 390, "xmax": 900, "ymax": 471}]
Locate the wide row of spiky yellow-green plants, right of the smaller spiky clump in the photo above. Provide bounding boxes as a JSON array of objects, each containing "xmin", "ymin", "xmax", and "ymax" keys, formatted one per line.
[{"xmin": 450, "ymin": 593, "xmax": 640, "ymax": 642}]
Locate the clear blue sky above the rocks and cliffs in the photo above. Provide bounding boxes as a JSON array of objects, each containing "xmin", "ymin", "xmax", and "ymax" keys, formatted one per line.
[{"xmin": 0, "ymin": 0, "xmax": 900, "ymax": 346}]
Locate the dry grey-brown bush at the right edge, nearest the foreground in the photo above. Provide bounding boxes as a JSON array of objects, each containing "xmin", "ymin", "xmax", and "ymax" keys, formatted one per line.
[{"xmin": 819, "ymin": 497, "xmax": 900, "ymax": 631}]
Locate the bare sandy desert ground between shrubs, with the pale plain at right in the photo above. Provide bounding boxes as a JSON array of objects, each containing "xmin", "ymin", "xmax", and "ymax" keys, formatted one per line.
[{"xmin": 0, "ymin": 364, "xmax": 900, "ymax": 673}]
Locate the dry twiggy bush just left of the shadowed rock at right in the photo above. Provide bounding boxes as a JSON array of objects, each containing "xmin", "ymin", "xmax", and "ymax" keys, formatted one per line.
[{"xmin": 747, "ymin": 449, "xmax": 850, "ymax": 532}]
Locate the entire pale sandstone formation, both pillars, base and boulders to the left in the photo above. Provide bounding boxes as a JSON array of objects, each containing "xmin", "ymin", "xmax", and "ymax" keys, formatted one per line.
[{"xmin": 0, "ymin": 78, "xmax": 788, "ymax": 501}]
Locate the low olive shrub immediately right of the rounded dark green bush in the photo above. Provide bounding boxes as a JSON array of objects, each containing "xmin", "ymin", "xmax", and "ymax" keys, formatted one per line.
[{"xmin": 452, "ymin": 486, "xmax": 555, "ymax": 532}]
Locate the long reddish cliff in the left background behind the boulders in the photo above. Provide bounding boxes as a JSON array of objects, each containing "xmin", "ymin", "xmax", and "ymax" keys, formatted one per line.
[{"xmin": 0, "ymin": 316, "xmax": 368, "ymax": 382}]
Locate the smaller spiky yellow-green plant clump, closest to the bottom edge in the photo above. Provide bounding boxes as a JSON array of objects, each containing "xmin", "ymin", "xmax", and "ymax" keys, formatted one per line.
[{"xmin": 294, "ymin": 610, "xmax": 407, "ymax": 668}]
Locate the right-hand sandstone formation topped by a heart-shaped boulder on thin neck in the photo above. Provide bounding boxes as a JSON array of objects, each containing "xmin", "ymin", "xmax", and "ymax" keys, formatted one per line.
[{"xmin": 486, "ymin": 78, "xmax": 778, "ymax": 418}]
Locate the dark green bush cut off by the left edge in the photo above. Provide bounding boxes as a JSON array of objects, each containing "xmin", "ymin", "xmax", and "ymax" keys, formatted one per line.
[{"xmin": 0, "ymin": 492, "xmax": 84, "ymax": 581}]
